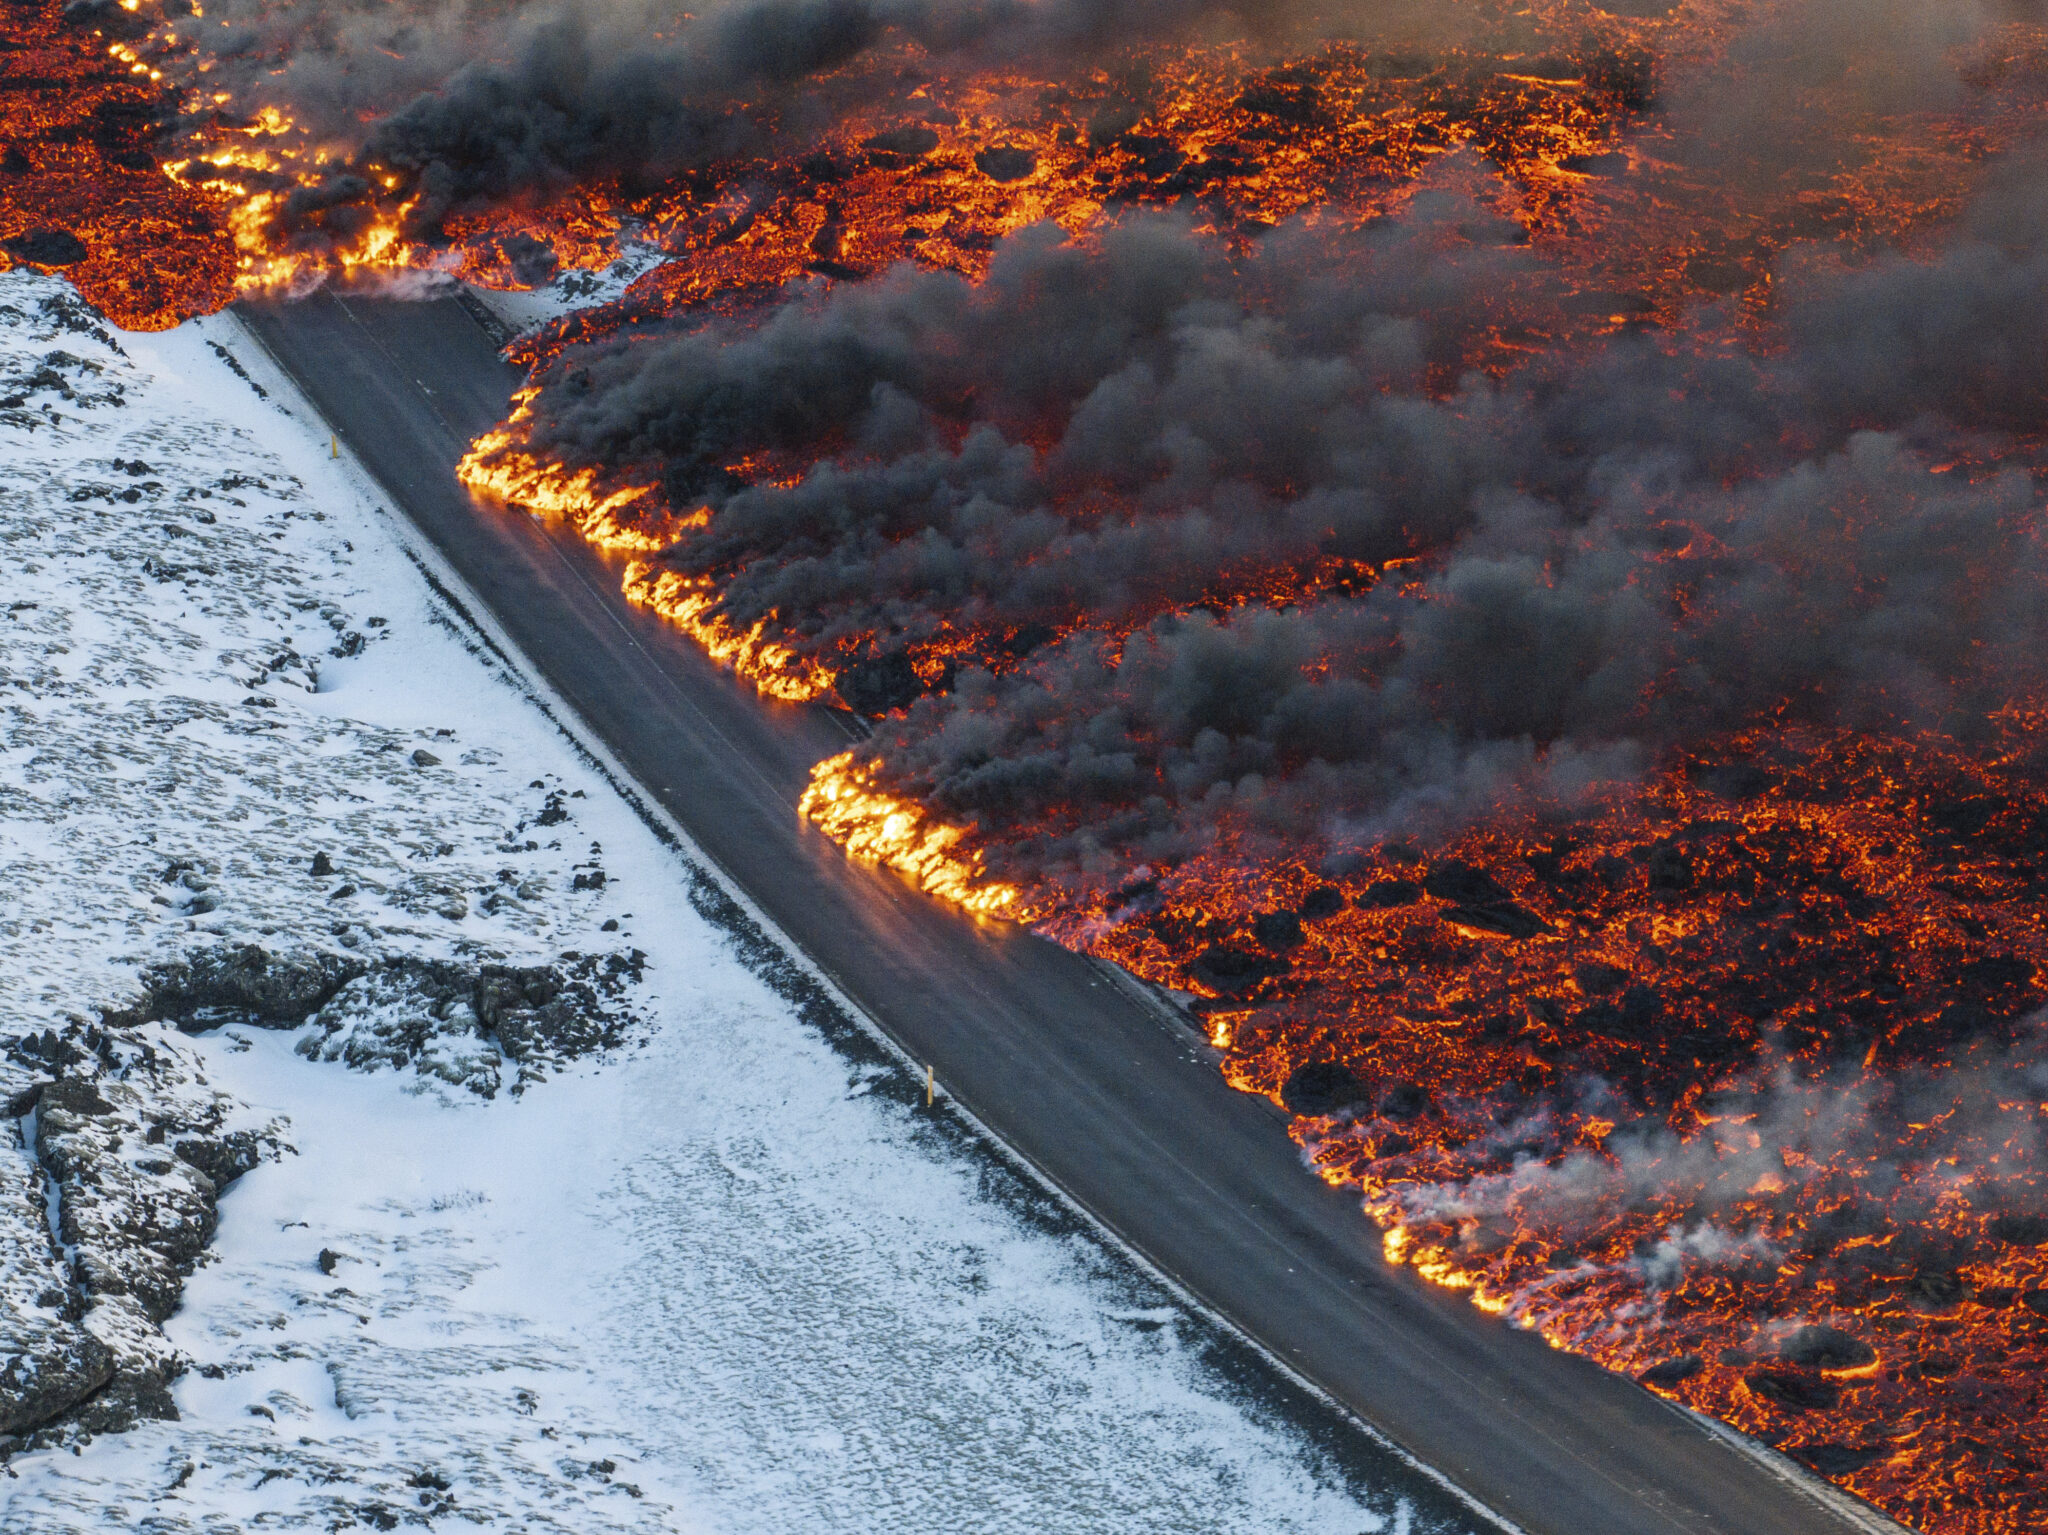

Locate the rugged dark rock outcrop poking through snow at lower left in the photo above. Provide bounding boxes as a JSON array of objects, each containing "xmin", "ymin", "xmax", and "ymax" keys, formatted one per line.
[{"xmin": 0, "ymin": 944, "xmax": 647, "ymax": 1459}]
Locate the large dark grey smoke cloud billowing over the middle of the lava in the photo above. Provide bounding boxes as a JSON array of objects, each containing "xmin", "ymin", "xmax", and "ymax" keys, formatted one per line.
[{"xmin": 507, "ymin": 176, "xmax": 2048, "ymax": 878}]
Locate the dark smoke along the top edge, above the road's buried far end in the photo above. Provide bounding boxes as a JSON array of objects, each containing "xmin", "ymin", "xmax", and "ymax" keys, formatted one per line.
[{"xmin": 176, "ymin": 0, "xmax": 1442, "ymax": 244}]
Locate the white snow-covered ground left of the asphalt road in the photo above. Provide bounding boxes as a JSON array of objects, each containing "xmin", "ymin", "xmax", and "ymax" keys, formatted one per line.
[{"xmin": 0, "ymin": 272, "xmax": 1474, "ymax": 1535}]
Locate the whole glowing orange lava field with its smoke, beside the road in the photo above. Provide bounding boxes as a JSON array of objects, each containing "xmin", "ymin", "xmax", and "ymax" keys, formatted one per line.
[{"xmin": 8, "ymin": 0, "xmax": 2048, "ymax": 1535}]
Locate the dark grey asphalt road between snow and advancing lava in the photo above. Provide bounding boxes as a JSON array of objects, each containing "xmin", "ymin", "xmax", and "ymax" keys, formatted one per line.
[{"xmin": 242, "ymin": 293, "xmax": 1900, "ymax": 1535}]
